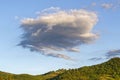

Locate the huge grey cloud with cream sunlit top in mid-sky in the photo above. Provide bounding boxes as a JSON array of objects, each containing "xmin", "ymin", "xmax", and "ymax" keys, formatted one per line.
[{"xmin": 19, "ymin": 8, "xmax": 99, "ymax": 59}]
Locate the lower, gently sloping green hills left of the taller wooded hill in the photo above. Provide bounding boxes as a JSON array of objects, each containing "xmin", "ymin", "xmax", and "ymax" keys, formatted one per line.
[{"xmin": 0, "ymin": 69, "xmax": 66, "ymax": 80}]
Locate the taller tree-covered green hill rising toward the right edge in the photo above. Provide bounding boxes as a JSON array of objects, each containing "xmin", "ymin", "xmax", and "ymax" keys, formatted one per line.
[{"xmin": 51, "ymin": 58, "xmax": 120, "ymax": 80}]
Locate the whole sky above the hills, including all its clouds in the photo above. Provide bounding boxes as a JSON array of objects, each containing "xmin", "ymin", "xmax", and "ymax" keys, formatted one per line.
[{"xmin": 0, "ymin": 0, "xmax": 120, "ymax": 74}]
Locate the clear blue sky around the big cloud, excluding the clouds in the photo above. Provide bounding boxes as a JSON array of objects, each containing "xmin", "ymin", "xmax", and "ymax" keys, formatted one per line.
[{"xmin": 0, "ymin": 0, "xmax": 120, "ymax": 74}]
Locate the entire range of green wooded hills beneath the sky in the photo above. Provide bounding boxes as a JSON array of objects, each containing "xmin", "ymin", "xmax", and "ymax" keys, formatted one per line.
[{"xmin": 0, "ymin": 58, "xmax": 120, "ymax": 80}]
